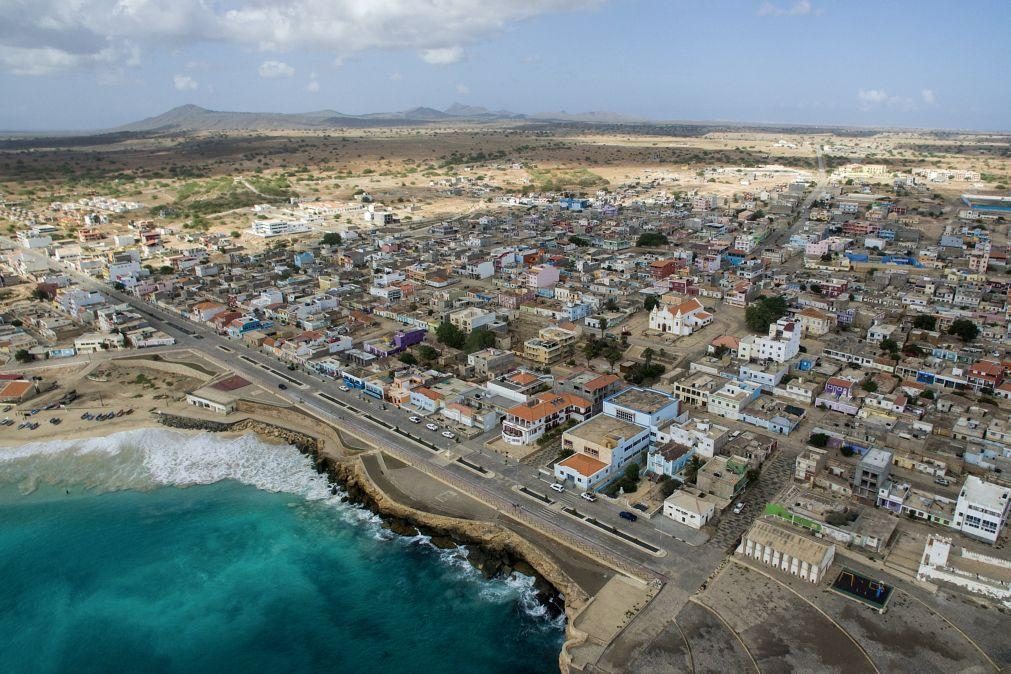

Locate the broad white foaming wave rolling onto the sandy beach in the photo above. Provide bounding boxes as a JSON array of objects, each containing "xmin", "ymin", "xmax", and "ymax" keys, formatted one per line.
[{"xmin": 0, "ymin": 428, "xmax": 334, "ymax": 500}]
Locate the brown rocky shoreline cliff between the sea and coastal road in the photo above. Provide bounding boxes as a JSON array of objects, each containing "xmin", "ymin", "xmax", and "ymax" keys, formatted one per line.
[{"xmin": 159, "ymin": 414, "xmax": 588, "ymax": 636}]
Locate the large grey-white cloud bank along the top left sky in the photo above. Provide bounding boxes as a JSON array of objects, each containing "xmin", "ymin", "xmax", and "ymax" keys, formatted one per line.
[{"xmin": 0, "ymin": 0, "xmax": 606, "ymax": 75}]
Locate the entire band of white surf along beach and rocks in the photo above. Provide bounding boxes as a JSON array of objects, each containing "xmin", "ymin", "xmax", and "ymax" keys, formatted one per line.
[{"xmin": 0, "ymin": 428, "xmax": 563, "ymax": 629}]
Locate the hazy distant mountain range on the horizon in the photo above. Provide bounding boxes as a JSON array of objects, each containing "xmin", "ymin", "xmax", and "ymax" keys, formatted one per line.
[{"xmin": 109, "ymin": 103, "xmax": 644, "ymax": 132}]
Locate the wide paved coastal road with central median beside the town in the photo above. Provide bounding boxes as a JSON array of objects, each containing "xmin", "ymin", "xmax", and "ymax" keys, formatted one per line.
[{"xmin": 7, "ymin": 241, "xmax": 718, "ymax": 578}]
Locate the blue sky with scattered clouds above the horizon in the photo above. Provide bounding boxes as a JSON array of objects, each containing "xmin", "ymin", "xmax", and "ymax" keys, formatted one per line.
[{"xmin": 0, "ymin": 0, "xmax": 1011, "ymax": 131}]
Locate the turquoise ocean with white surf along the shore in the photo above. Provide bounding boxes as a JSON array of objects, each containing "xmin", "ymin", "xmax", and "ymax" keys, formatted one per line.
[{"xmin": 0, "ymin": 429, "xmax": 564, "ymax": 673}]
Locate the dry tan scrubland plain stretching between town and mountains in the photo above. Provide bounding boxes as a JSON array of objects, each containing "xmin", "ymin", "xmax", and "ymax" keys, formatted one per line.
[{"xmin": 0, "ymin": 122, "xmax": 1011, "ymax": 246}]
